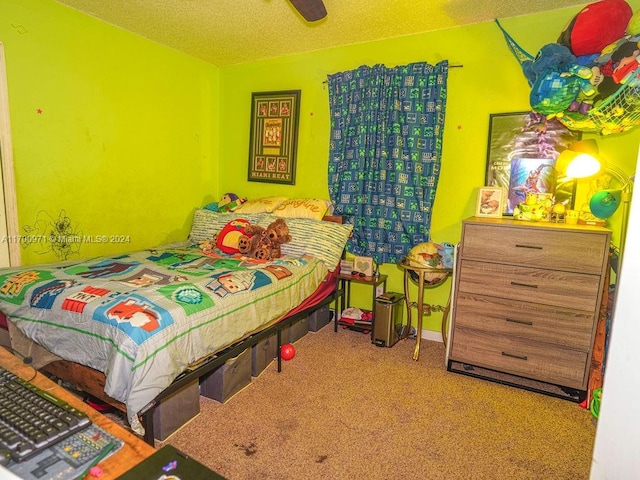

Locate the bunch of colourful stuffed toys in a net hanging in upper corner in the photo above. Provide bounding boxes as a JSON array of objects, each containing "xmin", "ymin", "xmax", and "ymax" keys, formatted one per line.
[{"xmin": 496, "ymin": 0, "xmax": 640, "ymax": 135}]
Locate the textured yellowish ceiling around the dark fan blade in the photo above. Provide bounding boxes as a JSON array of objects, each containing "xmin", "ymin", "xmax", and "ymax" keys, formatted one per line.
[{"xmin": 52, "ymin": 0, "xmax": 586, "ymax": 66}]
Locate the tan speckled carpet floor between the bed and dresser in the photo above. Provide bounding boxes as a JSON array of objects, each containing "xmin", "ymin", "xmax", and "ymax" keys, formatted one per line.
[{"xmin": 157, "ymin": 325, "xmax": 595, "ymax": 480}]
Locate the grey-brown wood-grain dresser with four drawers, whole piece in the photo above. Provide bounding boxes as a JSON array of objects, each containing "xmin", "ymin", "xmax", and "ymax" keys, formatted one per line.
[{"xmin": 447, "ymin": 217, "xmax": 611, "ymax": 401}]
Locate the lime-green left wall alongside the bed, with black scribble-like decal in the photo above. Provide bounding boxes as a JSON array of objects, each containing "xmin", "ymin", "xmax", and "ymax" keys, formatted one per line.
[{"xmin": 0, "ymin": 0, "xmax": 219, "ymax": 264}]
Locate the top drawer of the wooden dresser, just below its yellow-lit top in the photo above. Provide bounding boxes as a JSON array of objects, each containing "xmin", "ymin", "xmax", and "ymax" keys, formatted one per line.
[{"xmin": 461, "ymin": 224, "xmax": 609, "ymax": 275}]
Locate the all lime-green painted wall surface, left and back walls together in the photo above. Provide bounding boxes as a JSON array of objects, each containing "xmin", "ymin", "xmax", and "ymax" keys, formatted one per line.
[{"xmin": 0, "ymin": 0, "xmax": 640, "ymax": 332}]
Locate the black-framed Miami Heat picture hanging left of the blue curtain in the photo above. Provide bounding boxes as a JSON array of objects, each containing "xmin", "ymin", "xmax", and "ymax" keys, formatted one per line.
[{"xmin": 247, "ymin": 90, "xmax": 301, "ymax": 185}]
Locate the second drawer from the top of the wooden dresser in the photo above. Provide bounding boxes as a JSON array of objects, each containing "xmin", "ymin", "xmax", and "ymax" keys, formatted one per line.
[{"xmin": 458, "ymin": 259, "xmax": 600, "ymax": 312}]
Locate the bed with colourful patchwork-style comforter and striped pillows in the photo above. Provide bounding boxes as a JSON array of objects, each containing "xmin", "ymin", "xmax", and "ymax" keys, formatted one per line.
[{"xmin": 0, "ymin": 209, "xmax": 351, "ymax": 443}]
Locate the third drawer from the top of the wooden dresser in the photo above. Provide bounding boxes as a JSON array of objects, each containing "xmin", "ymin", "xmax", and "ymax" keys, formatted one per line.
[{"xmin": 454, "ymin": 293, "xmax": 593, "ymax": 352}]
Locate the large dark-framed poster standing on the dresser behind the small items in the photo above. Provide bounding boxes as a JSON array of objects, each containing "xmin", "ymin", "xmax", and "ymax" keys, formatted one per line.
[{"xmin": 484, "ymin": 112, "xmax": 582, "ymax": 215}]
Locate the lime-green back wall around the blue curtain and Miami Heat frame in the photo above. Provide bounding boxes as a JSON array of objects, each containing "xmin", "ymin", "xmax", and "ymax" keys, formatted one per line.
[{"xmin": 219, "ymin": 0, "xmax": 640, "ymax": 332}]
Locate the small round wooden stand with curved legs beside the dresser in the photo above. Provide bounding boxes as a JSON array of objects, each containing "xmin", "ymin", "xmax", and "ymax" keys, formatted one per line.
[{"xmin": 398, "ymin": 257, "xmax": 453, "ymax": 360}]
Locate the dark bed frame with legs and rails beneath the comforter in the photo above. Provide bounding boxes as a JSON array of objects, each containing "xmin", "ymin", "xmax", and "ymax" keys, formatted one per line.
[{"xmin": 40, "ymin": 216, "xmax": 344, "ymax": 445}]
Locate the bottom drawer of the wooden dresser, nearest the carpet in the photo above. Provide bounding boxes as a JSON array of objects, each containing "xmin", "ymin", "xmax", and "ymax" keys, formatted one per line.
[{"xmin": 451, "ymin": 327, "xmax": 588, "ymax": 390}]
